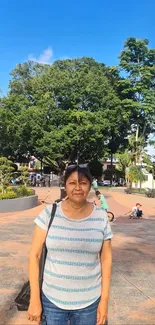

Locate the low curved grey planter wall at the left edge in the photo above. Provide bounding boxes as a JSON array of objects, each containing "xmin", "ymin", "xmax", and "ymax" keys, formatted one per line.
[{"xmin": 0, "ymin": 195, "xmax": 38, "ymax": 213}]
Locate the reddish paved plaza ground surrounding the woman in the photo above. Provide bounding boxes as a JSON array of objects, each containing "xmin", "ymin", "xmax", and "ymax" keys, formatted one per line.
[{"xmin": 0, "ymin": 188, "xmax": 155, "ymax": 325}]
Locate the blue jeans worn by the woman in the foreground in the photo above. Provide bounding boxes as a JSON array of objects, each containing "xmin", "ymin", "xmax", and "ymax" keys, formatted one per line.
[{"xmin": 41, "ymin": 293, "xmax": 103, "ymax": 325}]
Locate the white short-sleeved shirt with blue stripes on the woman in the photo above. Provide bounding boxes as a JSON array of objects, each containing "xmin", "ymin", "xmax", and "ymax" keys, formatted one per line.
[{"xmin": 35, "ymin": 203, "xmax": 112, "ymax": 310}]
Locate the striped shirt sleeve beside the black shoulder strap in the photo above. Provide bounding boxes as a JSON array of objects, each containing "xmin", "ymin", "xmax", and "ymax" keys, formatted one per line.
[{"xmin": 34, "ymin": 204, "xmax": 52, "ymax": 230}]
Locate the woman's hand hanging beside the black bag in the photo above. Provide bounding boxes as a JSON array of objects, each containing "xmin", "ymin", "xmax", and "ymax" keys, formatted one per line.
[{"xmin": 28, "ymin": 300, "xmax": 42, "ymax": 324}]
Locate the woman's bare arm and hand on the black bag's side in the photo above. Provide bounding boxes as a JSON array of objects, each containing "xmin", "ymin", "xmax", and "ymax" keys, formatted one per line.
[{"xmin": 28, "ymin": 226, "xmax": 47, "ymax": 323}]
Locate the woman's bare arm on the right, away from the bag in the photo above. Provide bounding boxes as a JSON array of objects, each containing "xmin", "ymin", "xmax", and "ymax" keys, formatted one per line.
[{"xmin": 97, "ymin": 239, "xmax": 112, "ymax": 325}]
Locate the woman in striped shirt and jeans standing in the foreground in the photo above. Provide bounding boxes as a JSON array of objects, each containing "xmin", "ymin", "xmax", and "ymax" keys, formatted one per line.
[{"xmin": 28, "ymin": 165, "xmax": 112, "ymax": 325}]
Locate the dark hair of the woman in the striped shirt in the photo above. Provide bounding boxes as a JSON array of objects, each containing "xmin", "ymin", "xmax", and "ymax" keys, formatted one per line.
[{"xmin": 64, "ymin": 165, "xmax": 92, "ymax": 187}]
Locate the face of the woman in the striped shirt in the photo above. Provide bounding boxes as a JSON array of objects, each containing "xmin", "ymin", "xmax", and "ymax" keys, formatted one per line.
[{"xmin": 66, "ymin": 171, "xmax": 90, "ymax": 203}]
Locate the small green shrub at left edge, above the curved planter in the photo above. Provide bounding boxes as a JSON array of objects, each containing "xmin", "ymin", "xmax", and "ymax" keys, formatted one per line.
[{"xmin": 0, "ymin": 157, "xmax": 14, "ymax": 194}]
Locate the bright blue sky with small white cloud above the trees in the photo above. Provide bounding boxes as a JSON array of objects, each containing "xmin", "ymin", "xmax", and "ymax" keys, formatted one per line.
[{"xmin": 0, "ymin": 0, "xmax": 155, "ymax": 95}]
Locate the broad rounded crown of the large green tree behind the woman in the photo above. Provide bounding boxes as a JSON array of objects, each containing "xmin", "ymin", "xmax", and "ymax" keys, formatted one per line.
[{"xmin": 0, "ymin": 58, "xmax": 130, "ymax": 167}]
